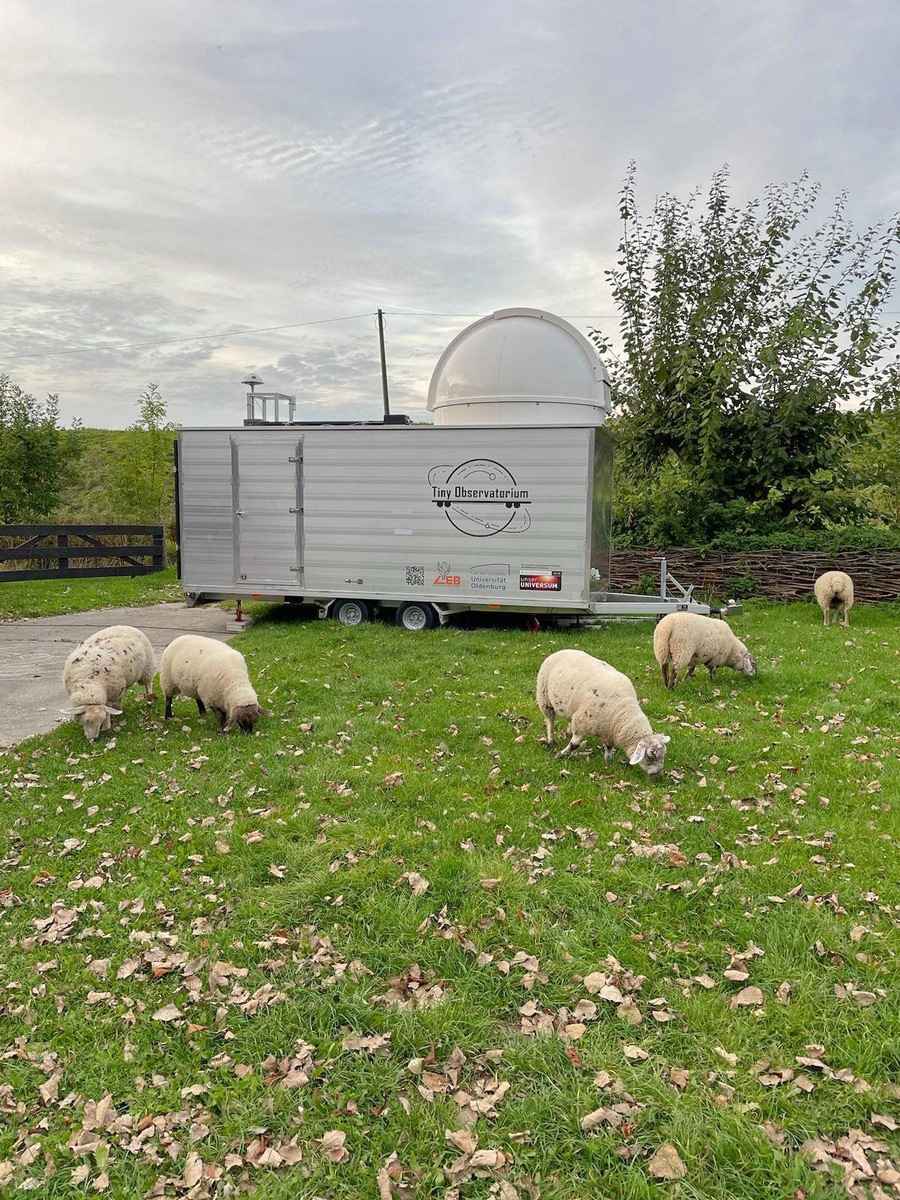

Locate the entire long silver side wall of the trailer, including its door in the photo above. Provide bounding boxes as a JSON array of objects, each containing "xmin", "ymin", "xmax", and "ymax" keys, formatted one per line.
[{"xmin": 180, "ymin": 426, "xmax": 594, "ymax": 611}]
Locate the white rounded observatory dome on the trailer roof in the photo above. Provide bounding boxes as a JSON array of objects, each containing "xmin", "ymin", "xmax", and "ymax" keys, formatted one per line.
[{"xmin": 428, "ymin": 308, "xmax": 611, "ymax": 425}]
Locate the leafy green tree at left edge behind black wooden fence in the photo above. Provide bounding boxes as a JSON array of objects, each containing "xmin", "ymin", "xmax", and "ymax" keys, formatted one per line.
[{"xmin": 0, "ymin": 376, "xmax": 79, "ymax": 524}]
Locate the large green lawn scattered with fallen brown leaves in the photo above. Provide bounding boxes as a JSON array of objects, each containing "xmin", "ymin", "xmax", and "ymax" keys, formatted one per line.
[{"xmin": 0, "ymin": 605, "xmax": 900, "ymax": 1200}]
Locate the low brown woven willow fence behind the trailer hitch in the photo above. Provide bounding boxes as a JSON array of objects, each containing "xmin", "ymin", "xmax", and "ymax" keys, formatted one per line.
[{"xmin": 610, "ymin": 547, "xmax": 900, "ymax": 602}]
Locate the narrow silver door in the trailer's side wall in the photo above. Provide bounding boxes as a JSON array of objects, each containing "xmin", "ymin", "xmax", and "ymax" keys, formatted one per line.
[{"xmin": 232, "ymin": 430, "xmax": 302, "ymax": 592}]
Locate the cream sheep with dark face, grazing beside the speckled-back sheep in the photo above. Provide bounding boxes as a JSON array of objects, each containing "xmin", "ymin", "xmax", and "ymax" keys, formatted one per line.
[{"xmin": 160, "ymin": 634, "xmax": 272, "ymax": 733}]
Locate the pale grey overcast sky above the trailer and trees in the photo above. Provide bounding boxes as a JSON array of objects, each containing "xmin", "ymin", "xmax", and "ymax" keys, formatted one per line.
[{"xmin": 0, "ymin": 0, "xmax": 900, "ymax": 426}]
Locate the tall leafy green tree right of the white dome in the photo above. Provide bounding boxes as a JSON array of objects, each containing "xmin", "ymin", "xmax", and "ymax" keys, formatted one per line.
[{"xmin": 592, "ymin": 163, "xmax": 900, "ymax": 540}]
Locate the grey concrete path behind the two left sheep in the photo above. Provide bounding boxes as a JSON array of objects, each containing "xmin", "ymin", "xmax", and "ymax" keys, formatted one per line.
[{"xmin": 0, "ymin": 604, "xmax": 240, "ymax": 746}]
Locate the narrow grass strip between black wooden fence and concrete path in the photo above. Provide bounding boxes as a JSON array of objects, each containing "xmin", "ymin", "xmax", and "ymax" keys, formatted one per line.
[{"xmin": 0, "ymin": 566, "xmax": 182, "ymax": 620}]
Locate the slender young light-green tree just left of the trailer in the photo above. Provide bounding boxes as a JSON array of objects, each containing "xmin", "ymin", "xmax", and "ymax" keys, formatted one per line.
[{"xmin": 112, "ymin": 383, "xmax": 176, "ymax": 524}]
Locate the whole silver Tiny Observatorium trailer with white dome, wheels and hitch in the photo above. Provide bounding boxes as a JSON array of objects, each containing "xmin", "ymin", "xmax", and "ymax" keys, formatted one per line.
[{"xmin": 176, "ymin": 308, "xmax": 710, "ymax": 629}]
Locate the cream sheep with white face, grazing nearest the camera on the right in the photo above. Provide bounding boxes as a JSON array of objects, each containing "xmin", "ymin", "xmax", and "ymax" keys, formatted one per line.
[{"xmin": 538, "ymin": 650, "xmax": 668, "ymax": 778}]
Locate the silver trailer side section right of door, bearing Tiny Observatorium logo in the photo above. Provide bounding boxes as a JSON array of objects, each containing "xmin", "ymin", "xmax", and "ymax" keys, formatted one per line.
[{"xmin": 304, "ymin": 426, "xmax": 592, "ymax": 608}]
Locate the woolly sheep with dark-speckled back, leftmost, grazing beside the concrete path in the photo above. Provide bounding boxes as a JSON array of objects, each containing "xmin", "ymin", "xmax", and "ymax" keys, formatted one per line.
[{"xmin": 61, "ymin": 625, "xmax": 156, "ymax": 742}]
